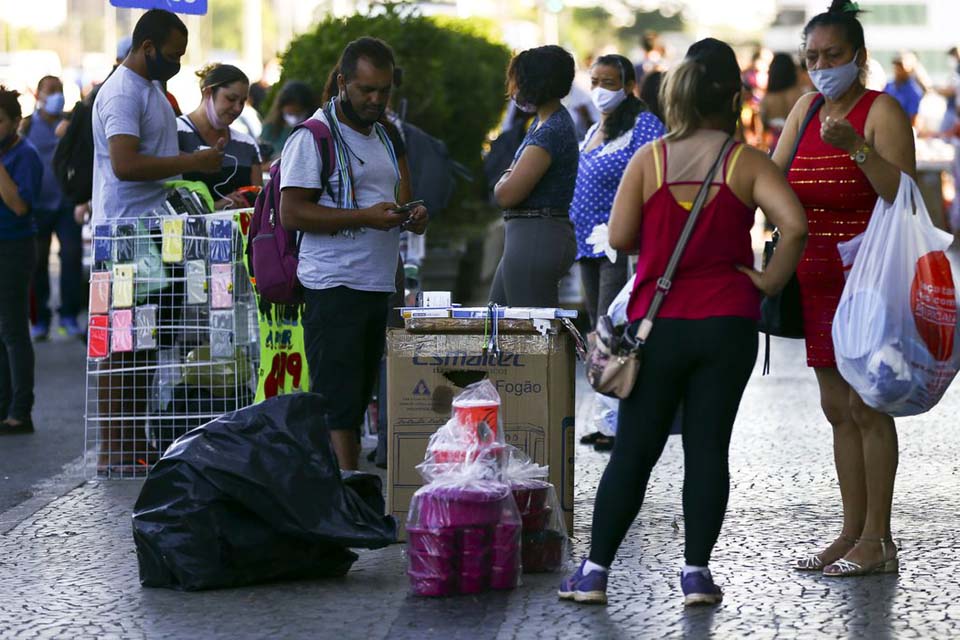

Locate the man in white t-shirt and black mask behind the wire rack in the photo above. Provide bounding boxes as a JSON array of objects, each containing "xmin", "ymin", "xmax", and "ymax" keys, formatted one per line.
[{"xmin": 91, "ymin": 9, "xmax": 226, "ymax": 477}]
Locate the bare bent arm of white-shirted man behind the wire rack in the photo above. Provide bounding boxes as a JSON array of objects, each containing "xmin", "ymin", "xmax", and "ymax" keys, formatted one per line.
[{"xmin": 109, "ymin": 135, "xmax": 226, "ymax": 182}]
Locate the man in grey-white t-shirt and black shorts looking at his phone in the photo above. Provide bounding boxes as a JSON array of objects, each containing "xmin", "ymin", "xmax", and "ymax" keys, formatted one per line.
[{"xmin": 280, "ymin": 38, "xmax": 428, "ymax": 470}]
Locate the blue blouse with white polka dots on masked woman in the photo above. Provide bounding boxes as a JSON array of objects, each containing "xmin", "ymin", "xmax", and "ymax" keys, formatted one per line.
[{"xmin": 570, "ymin": 111, "xmax": 664, "ymax": 260}]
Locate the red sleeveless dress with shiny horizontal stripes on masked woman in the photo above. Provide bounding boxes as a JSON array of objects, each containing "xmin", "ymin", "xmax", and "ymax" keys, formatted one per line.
[{"xmin": 787, "ymin": 91, "xmax": 880, "ymax": 367}]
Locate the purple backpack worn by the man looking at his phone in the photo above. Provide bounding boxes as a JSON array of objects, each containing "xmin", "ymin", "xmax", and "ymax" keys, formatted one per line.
[{"xmin": 247, "ymin": 118, "xmax": 337, "ymax": 304}]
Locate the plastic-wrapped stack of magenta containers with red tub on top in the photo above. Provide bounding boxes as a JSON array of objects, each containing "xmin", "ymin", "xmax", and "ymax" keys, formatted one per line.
[{"xmin": 407, "ymin": 382, "xmax": 522, "ymax": 596}]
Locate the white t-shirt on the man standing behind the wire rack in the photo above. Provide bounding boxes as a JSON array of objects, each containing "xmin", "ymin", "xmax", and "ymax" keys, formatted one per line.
[{"xmin": 91, "ymin": 65, "xmax": 180, "ymax": 220}]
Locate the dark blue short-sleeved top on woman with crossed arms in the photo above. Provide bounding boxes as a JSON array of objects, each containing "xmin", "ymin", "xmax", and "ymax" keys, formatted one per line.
[{"xmin": 513, "ymin": 107, "xmax": 580, "ymax": 209}]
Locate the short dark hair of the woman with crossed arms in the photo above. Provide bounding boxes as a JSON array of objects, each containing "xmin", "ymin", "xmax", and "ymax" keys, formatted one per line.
[{"xmin": 507, "ymin": 44, "xmax": 576, "ymax": 107}]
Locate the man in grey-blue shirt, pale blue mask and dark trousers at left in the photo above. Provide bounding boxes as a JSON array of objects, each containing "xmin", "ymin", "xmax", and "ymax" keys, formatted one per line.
[{"xmin": 20, "ymin": 76, "xmax": 84, "ymax": 341}]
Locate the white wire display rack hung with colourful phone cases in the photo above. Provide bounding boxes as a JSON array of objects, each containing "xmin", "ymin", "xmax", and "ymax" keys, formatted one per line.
[{"xmin": 84, "ymin": 212, "xmax": 260, "ymax": 478}]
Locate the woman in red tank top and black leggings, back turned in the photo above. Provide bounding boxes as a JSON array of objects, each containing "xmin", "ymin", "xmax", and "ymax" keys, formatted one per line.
[{"xmin": 559, "ymin": 38, "xmax": 807, "ymax": 604}]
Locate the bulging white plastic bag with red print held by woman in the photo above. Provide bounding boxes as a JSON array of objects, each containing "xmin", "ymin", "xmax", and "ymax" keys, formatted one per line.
[{"xmin": 833, "ymin": 174, "xmax": 960, "ymax": 416}]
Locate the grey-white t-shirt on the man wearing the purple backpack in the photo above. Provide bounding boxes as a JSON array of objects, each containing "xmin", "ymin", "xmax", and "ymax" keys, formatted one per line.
[{"xmin": 280, "ymin": 109, "xmax": 400, "ymax": 293}]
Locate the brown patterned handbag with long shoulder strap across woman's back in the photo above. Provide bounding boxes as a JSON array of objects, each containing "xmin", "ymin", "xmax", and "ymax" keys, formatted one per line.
[{"xmin": 586, "ymin": 138, "xmax": 734, "ymax": 400}]
